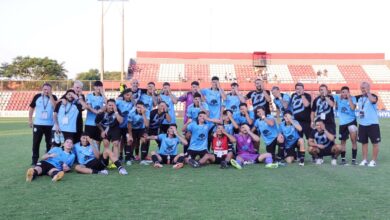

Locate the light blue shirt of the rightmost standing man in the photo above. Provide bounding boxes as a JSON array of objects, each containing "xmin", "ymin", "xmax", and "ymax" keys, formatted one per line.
[{"xmin": 356, "ymin": 94, "xmax": 379, "ymax": 126}]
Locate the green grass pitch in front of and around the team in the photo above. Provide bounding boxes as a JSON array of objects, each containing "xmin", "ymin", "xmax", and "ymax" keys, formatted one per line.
[{"xmin": 0, "ymin": 118, "xmax": 390, "ymax": 219}]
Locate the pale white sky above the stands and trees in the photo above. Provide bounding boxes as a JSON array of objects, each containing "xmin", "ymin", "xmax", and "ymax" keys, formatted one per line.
[{"xmin": 0, "ymin": 0, "xmax": 390, "ymax": 78}]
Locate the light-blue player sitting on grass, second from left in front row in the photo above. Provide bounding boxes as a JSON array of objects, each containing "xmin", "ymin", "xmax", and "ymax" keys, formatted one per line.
[{"xmin": 73, "ymin": 133, "xmax": 127, "ymax": 175}]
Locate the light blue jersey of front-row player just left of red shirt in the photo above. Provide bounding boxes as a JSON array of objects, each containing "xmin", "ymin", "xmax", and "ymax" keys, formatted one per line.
[{"xmin": 187, "ymin": 122, "xmax": 213, "ymax": 151}]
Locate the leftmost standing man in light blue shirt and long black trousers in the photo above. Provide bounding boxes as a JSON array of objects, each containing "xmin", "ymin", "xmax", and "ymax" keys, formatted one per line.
[{"xmin": 28, "ymin": 83, "xmax": 57, "ymax": 165}]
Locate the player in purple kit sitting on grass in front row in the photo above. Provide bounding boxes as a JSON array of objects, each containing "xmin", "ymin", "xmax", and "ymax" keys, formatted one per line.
[{"xmin": 230, "ymin": 124, "xmax": 278, "ymax": 169}]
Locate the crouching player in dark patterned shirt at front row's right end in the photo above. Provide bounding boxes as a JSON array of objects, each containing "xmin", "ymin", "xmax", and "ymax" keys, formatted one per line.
[{"xmin": 309, "ymin": 119, "xmax": 341, "ymax": 166}]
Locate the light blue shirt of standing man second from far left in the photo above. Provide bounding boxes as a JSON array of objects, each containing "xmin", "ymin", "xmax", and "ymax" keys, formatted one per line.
[{"xmin": 53, "ymin": 102, "xmax": 82, "ymax": 133}]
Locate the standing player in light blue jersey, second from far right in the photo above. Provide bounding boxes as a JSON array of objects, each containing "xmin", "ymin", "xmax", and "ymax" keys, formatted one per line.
[{"xmin": 335, "ymin": 86, "xmax": 357, "ymax": 165}]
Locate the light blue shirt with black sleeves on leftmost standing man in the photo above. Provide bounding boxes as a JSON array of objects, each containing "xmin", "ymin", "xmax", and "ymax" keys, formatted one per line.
[{"xmin": 30, "ymin": 93, "xmax": 57, "ymax": 126}]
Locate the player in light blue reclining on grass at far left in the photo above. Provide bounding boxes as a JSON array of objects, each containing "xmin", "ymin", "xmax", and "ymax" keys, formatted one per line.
[{"xmin": 26, "ymin": 139, "xmax": 75, "ymax": 182}]
